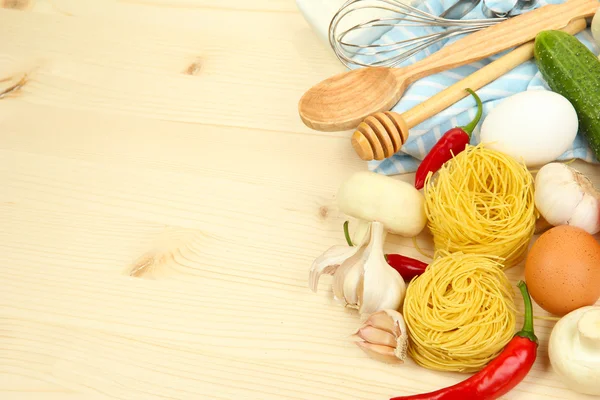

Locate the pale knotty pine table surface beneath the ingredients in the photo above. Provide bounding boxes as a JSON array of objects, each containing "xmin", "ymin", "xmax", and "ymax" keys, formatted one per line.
[{"xmin": 0, "ymin": 0, "xmax": 598, "ymax": 400}]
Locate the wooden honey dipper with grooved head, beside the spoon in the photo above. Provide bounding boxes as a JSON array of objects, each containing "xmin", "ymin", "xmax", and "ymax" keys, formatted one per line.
[{"xmin": 351, "ymin": 18, "xmax": 586, "ymax": 161}]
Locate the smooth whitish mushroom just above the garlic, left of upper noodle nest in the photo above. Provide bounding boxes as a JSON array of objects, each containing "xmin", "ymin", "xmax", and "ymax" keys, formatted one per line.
[{"xmin": 337, "ymin": 171, "xmax": 427, "ymax": 237}]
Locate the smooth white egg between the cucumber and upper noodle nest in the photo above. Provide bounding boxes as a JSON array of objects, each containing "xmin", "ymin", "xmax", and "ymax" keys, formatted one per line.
[{"xmin": 480, "ymin": 90, "xmax": 579, "ymax": 167}]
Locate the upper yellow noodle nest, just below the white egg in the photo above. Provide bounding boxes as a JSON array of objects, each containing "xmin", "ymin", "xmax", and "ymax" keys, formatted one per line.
[{"xmin": 424, "ymin": 144, "xmax": 538, "ymax": 268}]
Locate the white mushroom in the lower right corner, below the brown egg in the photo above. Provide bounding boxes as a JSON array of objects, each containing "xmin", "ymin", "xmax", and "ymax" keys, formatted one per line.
[{"xmin": 548, "ymin": 306, "xmax": 600, "ymax": 395}]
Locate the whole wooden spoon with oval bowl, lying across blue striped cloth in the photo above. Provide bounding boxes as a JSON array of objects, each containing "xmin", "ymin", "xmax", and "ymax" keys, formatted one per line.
[{"xmin": 298, "ymin": 0, "xmax": 600, "ymax": 132}]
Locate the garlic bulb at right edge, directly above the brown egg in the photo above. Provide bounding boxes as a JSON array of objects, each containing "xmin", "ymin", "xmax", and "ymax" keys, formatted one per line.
[{"xmin": 535, "ymin": 162, "xmax": 600, "ymax": 235}]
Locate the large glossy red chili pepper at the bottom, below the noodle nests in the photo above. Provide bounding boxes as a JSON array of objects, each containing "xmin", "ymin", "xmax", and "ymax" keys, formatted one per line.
[{"xmin": 391, "ymin": 281, "xmax": 538, "ymax": 400}]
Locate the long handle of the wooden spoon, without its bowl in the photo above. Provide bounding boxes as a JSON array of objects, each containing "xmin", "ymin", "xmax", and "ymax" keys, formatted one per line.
[{"xmin": 394, "ymin": 0, "xmax": 600, "ymax": 84}]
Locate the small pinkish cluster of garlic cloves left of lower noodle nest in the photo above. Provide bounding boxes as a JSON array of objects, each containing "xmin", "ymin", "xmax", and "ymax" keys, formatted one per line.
[{"xmin": 355, "ymin": 309, "xmax": 408, "ymax": 364}]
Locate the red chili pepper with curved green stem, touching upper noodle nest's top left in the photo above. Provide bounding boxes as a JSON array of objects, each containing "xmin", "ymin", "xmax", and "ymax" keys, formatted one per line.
[{"xmin": 415, "ymin": 89, "xmax": 483, "ymax": 189}]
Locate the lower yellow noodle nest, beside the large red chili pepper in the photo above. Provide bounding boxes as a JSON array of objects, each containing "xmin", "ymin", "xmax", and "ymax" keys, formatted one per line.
[{"xmin": 402, "ymin": 251, "xmax": 516, "ymax": 373}]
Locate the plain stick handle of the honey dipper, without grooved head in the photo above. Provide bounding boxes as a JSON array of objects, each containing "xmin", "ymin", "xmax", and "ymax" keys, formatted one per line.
[{"xmin": 402, "ymin": 18, "xmax": 586, "ymax": 129}]
